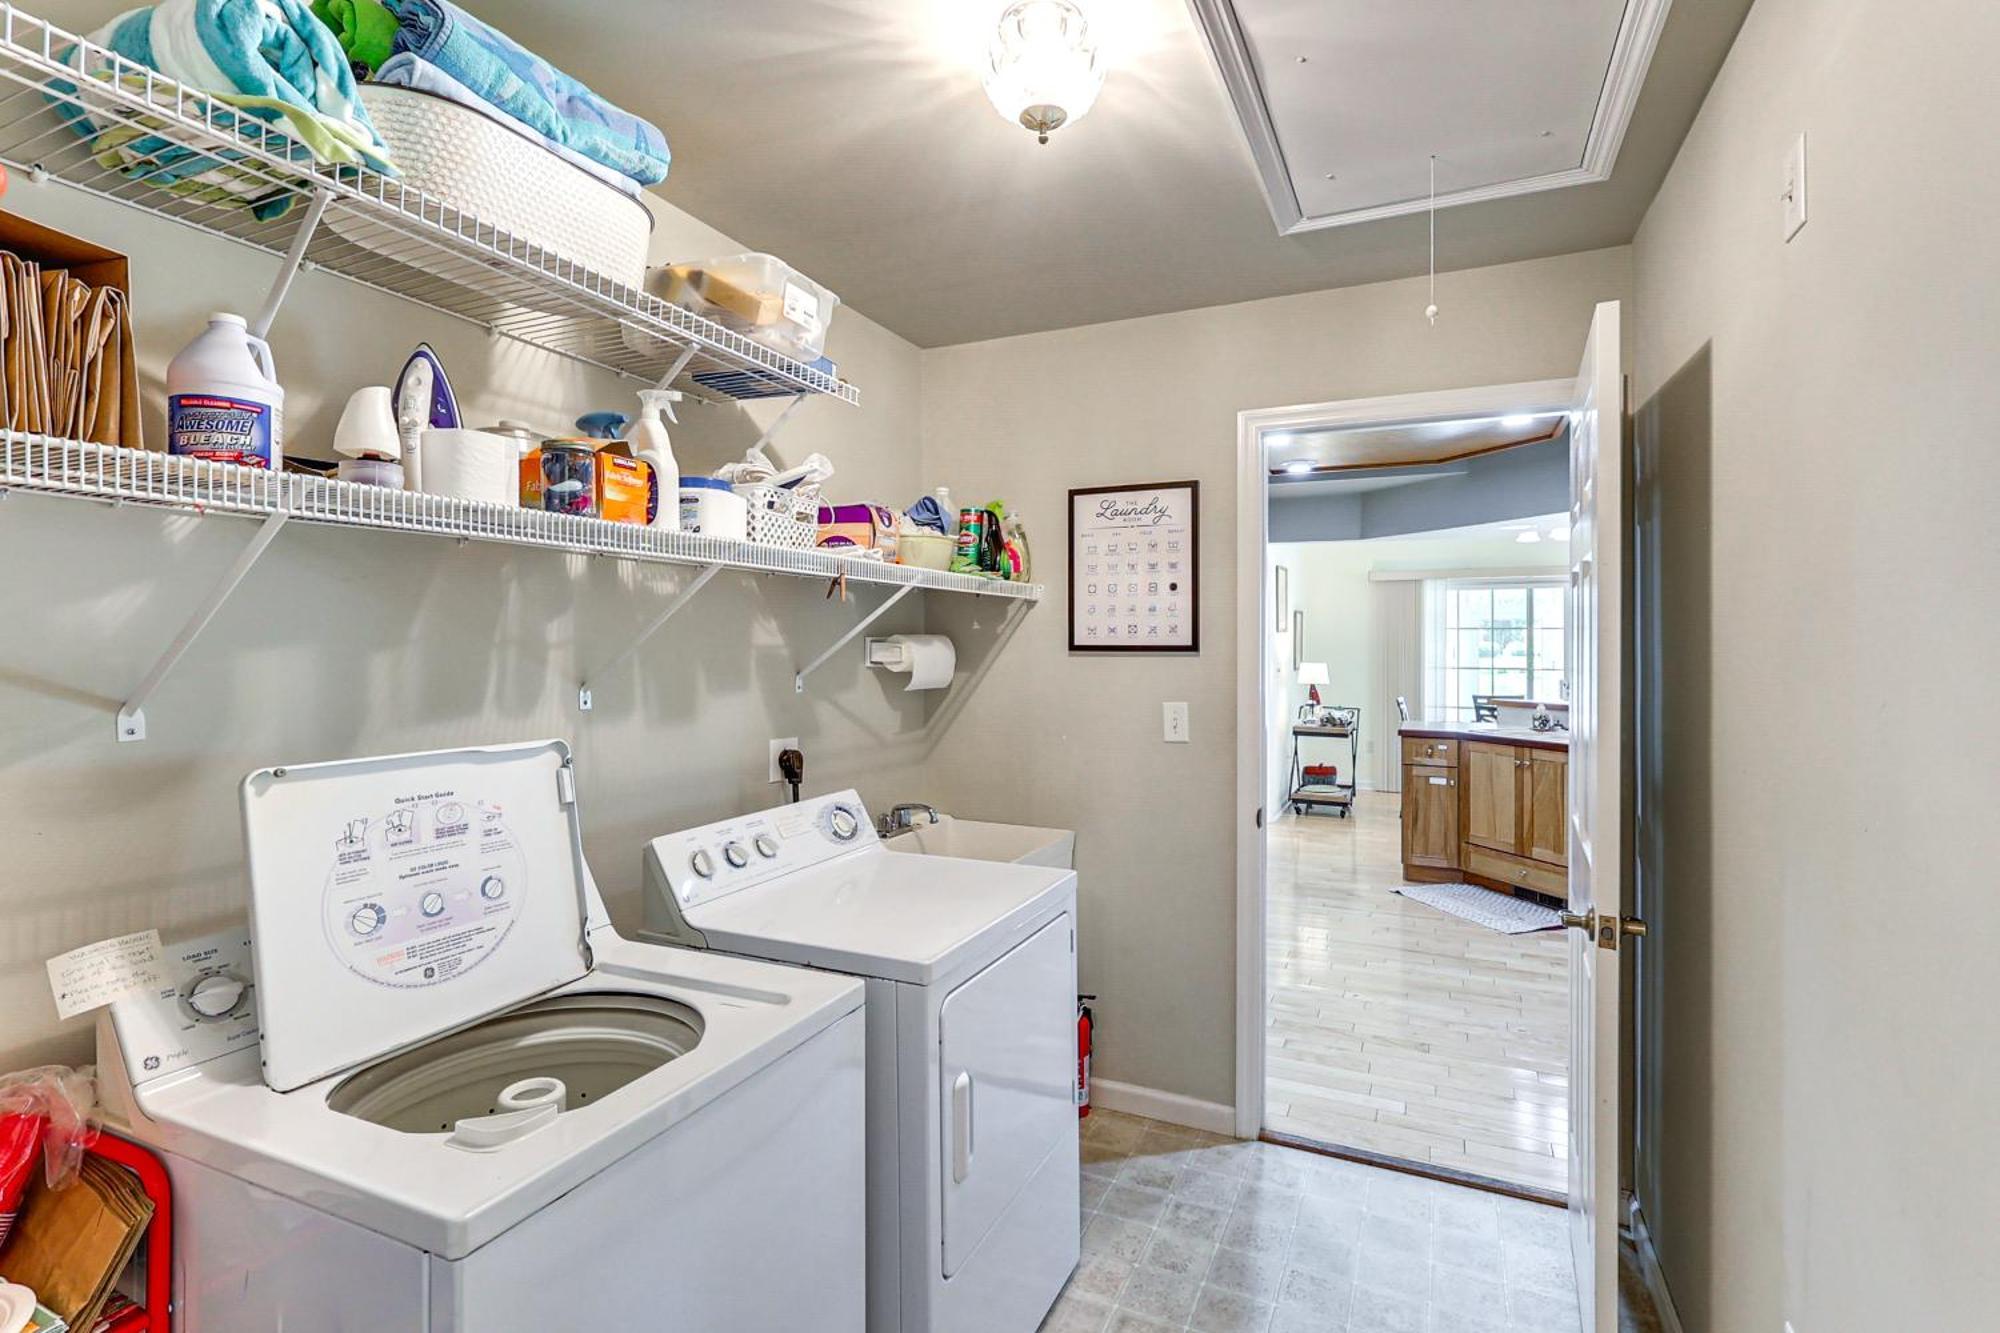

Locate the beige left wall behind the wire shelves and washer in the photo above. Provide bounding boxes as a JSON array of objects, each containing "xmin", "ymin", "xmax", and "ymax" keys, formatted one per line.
[{"xmin": 0, "ymin": 169, "xmax": 930, "ymax": 1069}]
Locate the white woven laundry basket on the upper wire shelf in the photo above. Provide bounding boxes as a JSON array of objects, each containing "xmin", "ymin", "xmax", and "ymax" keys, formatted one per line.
[{"xmin": 332, "ymin": 84, "xmax": 652, "ymax": 286}]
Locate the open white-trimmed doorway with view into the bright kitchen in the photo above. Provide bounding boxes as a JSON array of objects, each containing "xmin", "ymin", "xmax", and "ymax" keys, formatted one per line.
[{"xmin": 1240, "ymin": 380, "xmax": 1574, "ymax": 1201}]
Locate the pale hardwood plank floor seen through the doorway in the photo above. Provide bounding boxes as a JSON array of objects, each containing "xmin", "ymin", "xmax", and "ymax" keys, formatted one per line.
[{"xmin": 1264, "ymin": 791, "xmax": 1570, "ymax": 1193}]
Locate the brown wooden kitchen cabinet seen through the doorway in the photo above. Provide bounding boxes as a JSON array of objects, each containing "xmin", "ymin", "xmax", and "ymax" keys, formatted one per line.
[{"xmin": 1402, "ymin": 727, "xmax": 1570, "ymax": 899}]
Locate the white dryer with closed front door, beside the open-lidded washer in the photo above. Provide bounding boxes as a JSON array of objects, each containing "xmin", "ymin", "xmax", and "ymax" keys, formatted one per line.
[{"xmin": 644, "ymin": 791, "xmax": 1078, "ymax": 1333}]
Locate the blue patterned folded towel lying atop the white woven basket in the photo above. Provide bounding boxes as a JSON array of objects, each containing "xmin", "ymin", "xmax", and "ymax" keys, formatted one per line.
[{"xmin": 384, "ymin": 0, "xmax": 670, "ymax": 186}]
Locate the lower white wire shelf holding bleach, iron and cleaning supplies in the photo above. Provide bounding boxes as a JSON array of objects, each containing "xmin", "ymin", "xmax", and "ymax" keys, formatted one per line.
[{"xmin": 0, "ymin": 430, "xmax": 1042, "ymax": 602}]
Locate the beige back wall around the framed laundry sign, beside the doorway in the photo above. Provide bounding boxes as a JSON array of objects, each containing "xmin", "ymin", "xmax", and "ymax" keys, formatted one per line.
[{"xmin": 924, "ymin": 248, "xmax": 1630, "ymax": 1103}]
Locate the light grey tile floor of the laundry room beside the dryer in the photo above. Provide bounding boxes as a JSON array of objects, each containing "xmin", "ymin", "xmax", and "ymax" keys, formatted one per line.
[{"xmin": 1042, "ymin": 1111, "xmax": 1592, "ymax": 1333}]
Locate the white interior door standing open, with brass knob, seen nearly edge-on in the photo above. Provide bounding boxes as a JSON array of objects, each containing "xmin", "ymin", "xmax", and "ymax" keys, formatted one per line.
[{"xmin": 1564, "ymin": 300, "xmax": 1624, "ymax": 1333}]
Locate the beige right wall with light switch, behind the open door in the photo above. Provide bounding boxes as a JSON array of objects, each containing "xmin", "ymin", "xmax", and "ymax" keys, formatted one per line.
[{"xmin": 1634, "ymin": 0, "xmax": 2000, "ymax": 1333}]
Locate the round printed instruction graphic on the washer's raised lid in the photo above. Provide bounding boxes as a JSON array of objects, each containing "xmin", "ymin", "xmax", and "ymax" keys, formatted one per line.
[{"xmin": 320, "ymin": 793, "xmax": 528, "ymax": 989}]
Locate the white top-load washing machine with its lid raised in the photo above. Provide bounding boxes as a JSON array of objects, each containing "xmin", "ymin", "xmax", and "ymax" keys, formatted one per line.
[{"xmin": 98, "ymin": 743, "xmax": 866, "ymax": 1333}]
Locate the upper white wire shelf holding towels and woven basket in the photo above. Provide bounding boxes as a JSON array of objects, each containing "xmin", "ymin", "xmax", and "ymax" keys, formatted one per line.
[{"xmin": 0, "ymin": 2, "xmax": 860, "ymax": 404}]
